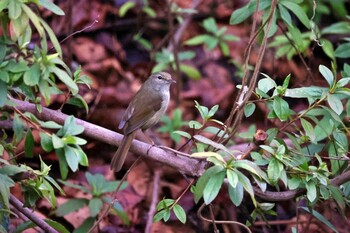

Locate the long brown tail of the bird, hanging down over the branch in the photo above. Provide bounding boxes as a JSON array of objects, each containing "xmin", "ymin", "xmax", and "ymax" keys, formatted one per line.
[{"xmin": 111, "ymin": 132, "xmax": 135, "ymax": 172}]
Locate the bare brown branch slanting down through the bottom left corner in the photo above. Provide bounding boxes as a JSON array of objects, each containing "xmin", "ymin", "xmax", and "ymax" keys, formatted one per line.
[{"xmin": 10, "ymin": 194, "xmax": 58, "ymax": 233}]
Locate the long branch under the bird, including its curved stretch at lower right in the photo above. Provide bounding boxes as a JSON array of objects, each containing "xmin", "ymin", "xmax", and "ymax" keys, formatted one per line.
[{"xmin": 6, "ymin": 99, "xmax": 350, "ymax": 201}]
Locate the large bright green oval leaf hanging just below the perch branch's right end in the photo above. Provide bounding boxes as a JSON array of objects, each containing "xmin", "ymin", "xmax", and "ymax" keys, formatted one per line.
[{"xmin": 203, "ymin": 170, "xmax": 225, "ymax": 205}]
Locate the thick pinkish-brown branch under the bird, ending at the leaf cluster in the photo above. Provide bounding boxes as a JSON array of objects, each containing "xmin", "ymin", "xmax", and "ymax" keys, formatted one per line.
[{"xmin": 5, "ymin": 99, "xmax": 205, "ymax": 176}]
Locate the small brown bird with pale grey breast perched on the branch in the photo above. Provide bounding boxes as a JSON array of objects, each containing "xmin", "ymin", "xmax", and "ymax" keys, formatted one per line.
[{"xmin": 111, "ymin": 72, "xmax": 175, "ymax": 172}]
